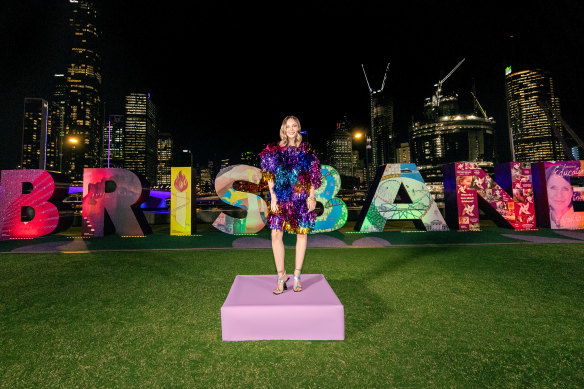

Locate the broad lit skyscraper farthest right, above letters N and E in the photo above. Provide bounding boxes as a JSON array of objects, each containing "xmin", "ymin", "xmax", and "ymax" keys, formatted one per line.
[{"xmin": 505, "ymin": 67, "xmax": 566, "ymax": 162}]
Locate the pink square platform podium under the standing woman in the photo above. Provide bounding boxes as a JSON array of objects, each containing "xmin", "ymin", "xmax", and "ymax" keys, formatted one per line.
[{"xmin": 221, "ymin": 274, "xmax": 345, "ymax": 341}]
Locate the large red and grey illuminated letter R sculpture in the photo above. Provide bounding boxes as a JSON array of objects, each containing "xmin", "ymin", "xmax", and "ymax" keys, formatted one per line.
[{"xmin": 81, "ymin": 168, "xmax": 152, "ymax": 237}]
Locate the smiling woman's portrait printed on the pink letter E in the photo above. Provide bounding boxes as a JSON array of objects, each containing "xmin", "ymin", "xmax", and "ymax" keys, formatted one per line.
[{"xmin": 546, "ymin": 166, "xmax": 584, "ymax": 229}]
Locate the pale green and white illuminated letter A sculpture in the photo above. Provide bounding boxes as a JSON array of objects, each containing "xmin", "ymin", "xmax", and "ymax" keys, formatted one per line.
[{"xmin": 355, "ymin": 163, "xmax": 448, "ymax": 232}]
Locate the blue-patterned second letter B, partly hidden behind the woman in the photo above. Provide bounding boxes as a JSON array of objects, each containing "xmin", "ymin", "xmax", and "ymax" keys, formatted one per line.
[{"xmin": 311, "ymin": 165, "xmax": 348, "ymax": 234}]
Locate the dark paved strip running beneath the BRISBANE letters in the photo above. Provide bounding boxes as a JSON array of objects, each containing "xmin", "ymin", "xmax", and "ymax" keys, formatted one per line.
[{"xmin": 0, "ymin": 227, "xmax": 584, "ymax": 254}]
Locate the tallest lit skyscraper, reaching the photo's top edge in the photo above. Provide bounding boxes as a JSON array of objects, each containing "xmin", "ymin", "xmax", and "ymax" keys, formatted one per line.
[{"xmin": 61, "ymin": 0, "xmax": 102, "ymax": 183}]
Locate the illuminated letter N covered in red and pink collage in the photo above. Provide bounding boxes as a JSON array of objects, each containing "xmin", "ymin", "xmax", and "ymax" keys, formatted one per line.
[{"xmin": 443, "ymin": 162, "xmax": 536, "ymax": 231}]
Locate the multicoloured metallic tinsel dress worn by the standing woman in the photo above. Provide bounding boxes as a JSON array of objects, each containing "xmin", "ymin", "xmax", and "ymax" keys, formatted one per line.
[{"xmin": 260, "ymin": 143, "xmax": 322, "ymax": 234}]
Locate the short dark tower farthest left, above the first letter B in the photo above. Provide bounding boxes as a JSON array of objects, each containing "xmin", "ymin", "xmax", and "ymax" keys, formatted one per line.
[{"xmin": 20, "ymin": 98, "xmax": 49, "ymax": 169}]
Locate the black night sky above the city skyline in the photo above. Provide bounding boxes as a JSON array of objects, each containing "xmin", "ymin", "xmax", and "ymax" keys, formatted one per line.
[{"xmin": 0, "ymin": 0, "xmax": 584, "ymax": 169}]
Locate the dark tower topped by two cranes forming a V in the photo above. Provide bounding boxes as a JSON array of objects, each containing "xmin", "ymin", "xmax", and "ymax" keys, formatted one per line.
[{"xmin": 361, "ymin": 63, "xmax": 397, "ymax": 167}]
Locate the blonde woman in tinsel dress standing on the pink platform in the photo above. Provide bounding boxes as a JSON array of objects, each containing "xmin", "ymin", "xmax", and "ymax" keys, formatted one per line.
[{"xmin": 260, "ymin": 116, "xmax": 322, "ymax": 295}]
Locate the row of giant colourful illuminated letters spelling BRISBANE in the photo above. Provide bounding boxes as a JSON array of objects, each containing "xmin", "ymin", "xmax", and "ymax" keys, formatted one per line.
[{"xmin": 0, "ymin": 161, "xmax": 584, "ymax": 240}]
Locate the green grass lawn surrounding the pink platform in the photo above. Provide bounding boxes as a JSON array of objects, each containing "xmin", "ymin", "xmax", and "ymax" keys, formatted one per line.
[{"xmin": 0, "ymin": 244, "xmax": 584, "ymax": 388}]
